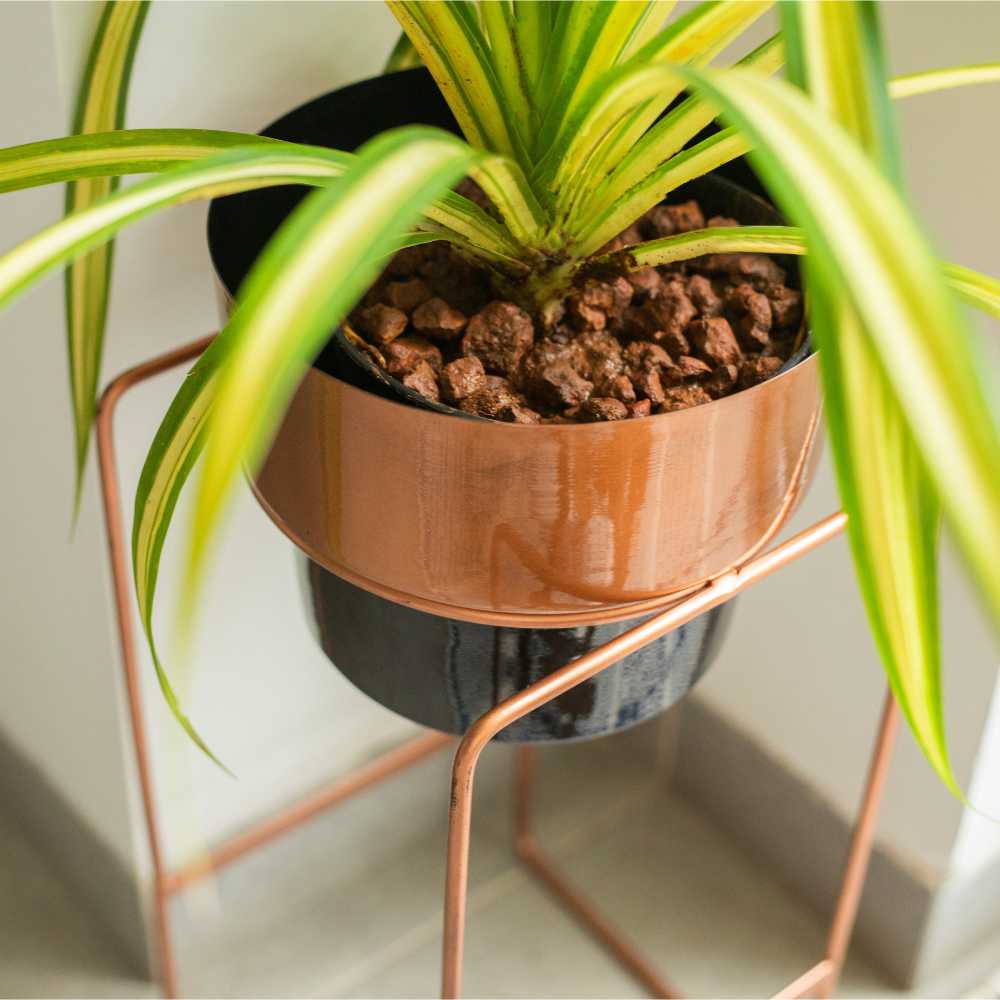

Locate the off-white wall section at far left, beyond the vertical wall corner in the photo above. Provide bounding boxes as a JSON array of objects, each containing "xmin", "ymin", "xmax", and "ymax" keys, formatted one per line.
[{"xmin": 0, "ymin": 4, "xmax": 141, "ymax": 876}]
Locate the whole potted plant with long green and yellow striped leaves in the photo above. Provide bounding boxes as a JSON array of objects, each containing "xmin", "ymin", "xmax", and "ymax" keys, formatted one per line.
[{"xmin": 0, "ymin": 0, "xmax": 1000, "ymax": 790}]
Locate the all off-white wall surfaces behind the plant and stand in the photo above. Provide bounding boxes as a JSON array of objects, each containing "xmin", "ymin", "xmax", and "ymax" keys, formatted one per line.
[{"xmin": 0, "ymin": 3, "xmax": 1000, "ymax": 892}]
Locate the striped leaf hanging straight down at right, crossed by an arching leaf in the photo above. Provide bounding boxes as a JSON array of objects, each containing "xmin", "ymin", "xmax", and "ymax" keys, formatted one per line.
[{"xmin": 782, "ymin": 0, "xmax": 944, "ymax": 780}]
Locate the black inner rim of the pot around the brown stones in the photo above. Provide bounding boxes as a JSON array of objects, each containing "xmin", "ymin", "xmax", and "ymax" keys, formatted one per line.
[{"xmin": 207, "ymin": 68, "xmax": 813, "ymax": 433}]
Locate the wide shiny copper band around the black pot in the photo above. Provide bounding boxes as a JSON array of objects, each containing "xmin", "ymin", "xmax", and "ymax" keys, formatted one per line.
[{"xmin": 255, "ymin": 356, "xmax": 819, "ymax": 627}]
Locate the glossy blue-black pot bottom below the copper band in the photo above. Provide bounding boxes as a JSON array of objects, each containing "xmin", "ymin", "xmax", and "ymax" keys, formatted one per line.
[{"xmin": 304, "ymin": 560, "xmax": 732, "ymax": 743}]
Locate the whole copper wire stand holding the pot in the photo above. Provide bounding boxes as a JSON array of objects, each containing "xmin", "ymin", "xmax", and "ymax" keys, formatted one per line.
[{"xmin": 96, "ymin": 336, "xmax": 899, "ymax": 1000}]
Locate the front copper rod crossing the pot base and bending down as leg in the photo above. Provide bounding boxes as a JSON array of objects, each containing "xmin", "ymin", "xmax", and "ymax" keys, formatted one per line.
[{"xmin": 441, "ymin": 513, "xmax": 847, "ymax": 1000}]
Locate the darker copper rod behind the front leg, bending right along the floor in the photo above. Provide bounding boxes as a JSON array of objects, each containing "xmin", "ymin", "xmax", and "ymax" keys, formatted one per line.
[{"xmin": 514, "ymin": 746, "xmax": 680, "ymax": 1000}]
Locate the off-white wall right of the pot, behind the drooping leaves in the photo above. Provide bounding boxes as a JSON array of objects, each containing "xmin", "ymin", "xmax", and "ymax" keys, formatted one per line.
[{"xmin": 701, "ymin": 2, "xmax": 1000, "ymax": 872}]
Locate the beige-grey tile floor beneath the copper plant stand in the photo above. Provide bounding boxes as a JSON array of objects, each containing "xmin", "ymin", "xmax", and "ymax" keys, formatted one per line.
[{"xmin": 0, "ymin": 728, "xmax": 1000, "ymax": 998}]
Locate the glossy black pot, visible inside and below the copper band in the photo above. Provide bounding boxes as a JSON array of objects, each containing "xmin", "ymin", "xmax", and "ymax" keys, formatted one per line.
[{"xmin": 208, "ymin": 70, "xmax": 798, "ymax": 741}]
